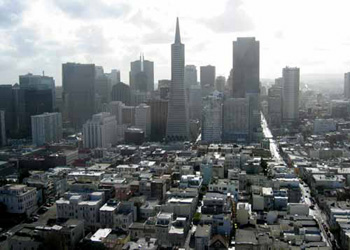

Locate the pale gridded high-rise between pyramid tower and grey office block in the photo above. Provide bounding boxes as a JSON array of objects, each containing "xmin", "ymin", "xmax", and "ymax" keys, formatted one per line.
[{"xmin": 202, "ymin": 95, "xmax": 222, "ymax": 142}]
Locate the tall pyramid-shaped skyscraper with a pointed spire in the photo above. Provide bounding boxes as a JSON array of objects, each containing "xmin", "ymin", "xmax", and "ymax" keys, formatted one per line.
[{"xmin": 167, "ymin": 19, "xmax": 189, "ymax": 141}]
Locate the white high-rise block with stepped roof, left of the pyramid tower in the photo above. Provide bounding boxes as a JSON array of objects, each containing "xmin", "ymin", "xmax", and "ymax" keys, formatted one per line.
[{"xmin": 83, "ymin": 112, "xmax": 117, "ymax": 148}]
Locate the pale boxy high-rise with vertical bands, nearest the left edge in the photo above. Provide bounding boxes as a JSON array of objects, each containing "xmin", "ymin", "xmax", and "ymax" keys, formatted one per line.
[{"xmin": 31, "ymin": 113, "xmax": 62, "ymax": 146}]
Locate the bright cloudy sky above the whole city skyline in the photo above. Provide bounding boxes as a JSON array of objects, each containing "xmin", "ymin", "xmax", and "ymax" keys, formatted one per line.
[{"xmin": 0, "ymin": 0, "xmax": 350, "ymax": 85}]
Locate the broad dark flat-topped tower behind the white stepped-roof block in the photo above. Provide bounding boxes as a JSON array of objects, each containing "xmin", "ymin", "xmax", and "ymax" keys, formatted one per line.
[{"xmin": 62, "ymin": 63, "xmax": 96, "ymax": 130}]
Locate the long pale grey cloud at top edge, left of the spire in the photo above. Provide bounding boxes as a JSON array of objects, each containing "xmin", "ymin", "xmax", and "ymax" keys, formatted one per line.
[{"xmin": 53, "ymin": 0, "xmax": 130, "ymax": 19}]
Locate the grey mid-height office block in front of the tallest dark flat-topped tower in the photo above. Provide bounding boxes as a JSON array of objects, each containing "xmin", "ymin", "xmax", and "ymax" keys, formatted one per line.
[{"xmin": 222, "ymin": 97, "xmax": 250, "ymax": 143}]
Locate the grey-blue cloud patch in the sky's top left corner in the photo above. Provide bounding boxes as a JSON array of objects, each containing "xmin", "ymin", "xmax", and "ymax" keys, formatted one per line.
[{"xmin": 0, "ymin": 0, "xmax": 25, "ymax": 28}]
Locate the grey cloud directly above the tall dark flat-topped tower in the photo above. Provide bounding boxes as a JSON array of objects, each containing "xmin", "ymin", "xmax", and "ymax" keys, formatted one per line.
[{"xmin": 204, "ymin": 0, "xmax": 254, "ymax": 33}]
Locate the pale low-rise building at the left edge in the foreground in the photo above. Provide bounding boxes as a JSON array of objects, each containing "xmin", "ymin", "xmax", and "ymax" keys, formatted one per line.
[{"xmin": 0, "ymin": 184, "xmax": 37, "ymax": 215}]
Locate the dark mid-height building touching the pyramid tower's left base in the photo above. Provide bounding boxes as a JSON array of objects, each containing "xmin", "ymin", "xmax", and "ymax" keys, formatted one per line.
[{"xmin": 148, "ymin": 99, "xmax": 168, "ymax": 141}]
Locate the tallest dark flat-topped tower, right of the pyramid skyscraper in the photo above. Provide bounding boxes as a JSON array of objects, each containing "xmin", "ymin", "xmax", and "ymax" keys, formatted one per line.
[{"xmin": 231, "ymin": 37, "xmax": 261, "ymax": 141}]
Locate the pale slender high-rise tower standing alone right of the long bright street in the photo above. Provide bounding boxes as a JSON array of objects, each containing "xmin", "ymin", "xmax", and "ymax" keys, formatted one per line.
[{"xmin": 282, "ymin": 67, "xmax": 300, "ymax": 122}]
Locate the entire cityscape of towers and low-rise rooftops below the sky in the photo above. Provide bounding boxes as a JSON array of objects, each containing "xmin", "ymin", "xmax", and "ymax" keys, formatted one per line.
[{"xmin": 0, "ymin": 17, "xmax": 350, "ymax": 250}]
